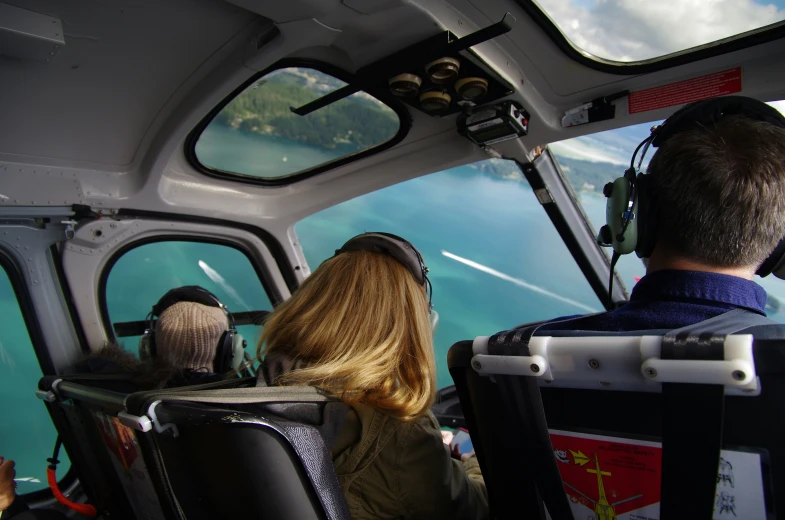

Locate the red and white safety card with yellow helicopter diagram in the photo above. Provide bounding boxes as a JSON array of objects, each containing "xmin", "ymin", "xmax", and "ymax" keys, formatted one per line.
[{"xmin": 551, "ymin": 430, "xmax": 766, "ymax": 520}]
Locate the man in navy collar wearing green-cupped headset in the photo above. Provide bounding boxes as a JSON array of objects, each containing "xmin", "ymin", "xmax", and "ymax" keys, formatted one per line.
[{"xmin": 539, "ymin": 96, "xmax": 785, "ymax": 331}]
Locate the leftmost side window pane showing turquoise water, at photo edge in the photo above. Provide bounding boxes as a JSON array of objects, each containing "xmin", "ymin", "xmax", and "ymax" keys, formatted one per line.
[{"xmin": 0, "ymin": 269, "xmax": 71, "ymax": 495}]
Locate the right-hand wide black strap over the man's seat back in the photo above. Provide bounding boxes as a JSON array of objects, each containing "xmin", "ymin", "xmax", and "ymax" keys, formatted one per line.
[{"xmin": 660, "ymin": 309, "xmax": 774, "ymax": 520}]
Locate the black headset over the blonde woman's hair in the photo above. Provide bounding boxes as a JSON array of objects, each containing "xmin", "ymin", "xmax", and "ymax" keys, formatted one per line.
[{"xmin": 334, "ymin": 232, "xmax": 436, "ymax": 314}]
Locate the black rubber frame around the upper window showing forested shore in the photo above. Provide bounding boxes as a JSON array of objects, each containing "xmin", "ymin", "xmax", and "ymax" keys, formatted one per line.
[{"xmin": 185, "ymin": 58, "xmax": 412, "ymax": 186}]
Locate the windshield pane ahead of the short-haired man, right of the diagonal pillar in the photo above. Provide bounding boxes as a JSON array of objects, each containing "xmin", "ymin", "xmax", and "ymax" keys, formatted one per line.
[{"xmin": 549, "ymin": 97, "xmax": 785, "ymax": 322}]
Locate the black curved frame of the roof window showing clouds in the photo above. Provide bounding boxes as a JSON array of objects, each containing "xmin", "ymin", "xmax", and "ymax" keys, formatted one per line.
[{"xmin": 515, "ymin": 0, "xmax": 785, "ymax": 75}]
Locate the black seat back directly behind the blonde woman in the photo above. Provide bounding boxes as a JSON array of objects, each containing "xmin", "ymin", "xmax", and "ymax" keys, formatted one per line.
[{"xmin": 135, "ymin": 402, "xmax": 348, "ymax": 520}]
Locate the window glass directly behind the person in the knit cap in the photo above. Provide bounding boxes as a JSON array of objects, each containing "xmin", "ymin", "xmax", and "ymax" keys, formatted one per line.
[{"xmin": 106, "ymin": 241, "xmax": 272, "ymax": 355}]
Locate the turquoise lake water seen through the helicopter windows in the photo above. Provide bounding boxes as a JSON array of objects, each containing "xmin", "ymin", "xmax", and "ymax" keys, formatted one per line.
[{"xmin": 6, "ymin": 131, "xmax": 785, "ymax": 492}]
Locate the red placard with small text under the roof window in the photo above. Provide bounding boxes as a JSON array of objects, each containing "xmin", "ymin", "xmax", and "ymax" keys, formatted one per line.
[{"xmin": 628, "ymin": 67, "xmax": 741, "ymax": 114}]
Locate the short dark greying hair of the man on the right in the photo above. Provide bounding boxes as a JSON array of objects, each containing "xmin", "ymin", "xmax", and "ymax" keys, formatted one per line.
[{"xmin": 648, "ymin": 115, "xmax": 785, "ymax": 268}]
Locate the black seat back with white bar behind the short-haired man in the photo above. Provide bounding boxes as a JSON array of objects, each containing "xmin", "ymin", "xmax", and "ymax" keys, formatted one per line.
[{"xmin": 448, "ymin": 312, "xmax": 785, "ymax": 520}]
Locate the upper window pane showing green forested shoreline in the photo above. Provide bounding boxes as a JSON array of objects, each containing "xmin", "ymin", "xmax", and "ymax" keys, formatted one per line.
[{"xmin": 194, "ymin": 67, "xmax": 401, "ymax": 183}]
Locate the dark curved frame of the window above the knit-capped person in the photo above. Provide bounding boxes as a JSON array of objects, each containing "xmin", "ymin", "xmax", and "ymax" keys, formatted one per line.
[{"xmin": 98, "ymin": 235, "xmax": 281, "ymax": 341}]
